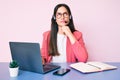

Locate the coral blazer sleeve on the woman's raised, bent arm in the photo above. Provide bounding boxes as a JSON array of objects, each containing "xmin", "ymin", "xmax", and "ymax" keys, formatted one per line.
[{"xmin": 72, "ymin": 32, "xmax": 88, "ymax": 62}]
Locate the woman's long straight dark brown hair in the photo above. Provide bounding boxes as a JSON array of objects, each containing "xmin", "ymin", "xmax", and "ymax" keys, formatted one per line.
[{"xmin": 49, "ymin": 4, "xmax": 75, "ymax": 56}]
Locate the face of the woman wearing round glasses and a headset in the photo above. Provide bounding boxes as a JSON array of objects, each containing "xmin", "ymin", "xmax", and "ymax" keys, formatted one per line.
[{"xmin": 56, "ymin": 6, "xmax": 70, "ymax": 27}]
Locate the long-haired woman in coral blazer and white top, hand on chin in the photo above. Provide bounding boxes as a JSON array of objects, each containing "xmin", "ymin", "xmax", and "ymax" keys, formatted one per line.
[{"xmin": 41, "ymin": 4, "xmax": 88, "ymax": 63}]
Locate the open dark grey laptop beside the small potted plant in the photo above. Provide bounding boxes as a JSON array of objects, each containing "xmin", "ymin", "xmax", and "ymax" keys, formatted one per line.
[{"xmin": 9, "ymin": 42, "xmax": 60, "ymax": 74}]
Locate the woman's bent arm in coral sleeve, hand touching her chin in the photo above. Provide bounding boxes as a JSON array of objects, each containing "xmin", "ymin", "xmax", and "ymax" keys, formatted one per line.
[{"xmin": 62, "ymin": 26, "xmax": 88, "ymax": 62}]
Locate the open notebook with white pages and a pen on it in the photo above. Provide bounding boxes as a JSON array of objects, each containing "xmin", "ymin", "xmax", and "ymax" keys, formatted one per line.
[{"xmin": 70, "ymin": 61, "xmax": 117, "ymax": 73}]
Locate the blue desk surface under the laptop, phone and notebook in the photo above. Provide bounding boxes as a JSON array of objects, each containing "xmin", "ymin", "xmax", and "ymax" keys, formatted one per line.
[{"xmin": 0, "ymin": 62, "xmax": 120, "ymax": 80}]
